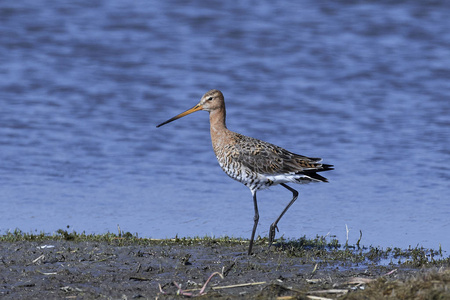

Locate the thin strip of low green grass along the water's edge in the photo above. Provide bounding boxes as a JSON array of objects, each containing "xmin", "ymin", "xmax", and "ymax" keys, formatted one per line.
[{"xmin": 0, "ymin": 229, "xmax": 450, "ymax": 267}]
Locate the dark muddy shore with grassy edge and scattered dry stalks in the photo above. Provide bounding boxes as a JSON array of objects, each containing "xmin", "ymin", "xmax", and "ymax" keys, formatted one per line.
[{"xmin": 0, "ymin": 230, "xmax": 450, "ymax": 299}]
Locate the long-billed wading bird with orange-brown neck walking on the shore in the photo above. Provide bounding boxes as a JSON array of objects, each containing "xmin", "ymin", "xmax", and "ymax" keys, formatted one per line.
[{"xmin": 156, "ymin": 89, "xmax": 334, "ymax": 255}]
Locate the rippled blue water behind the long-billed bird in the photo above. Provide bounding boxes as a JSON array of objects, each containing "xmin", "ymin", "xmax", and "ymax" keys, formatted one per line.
[{"xmin": 0, "ymin": 0, "xmax": 450, "ymax": 254}]
